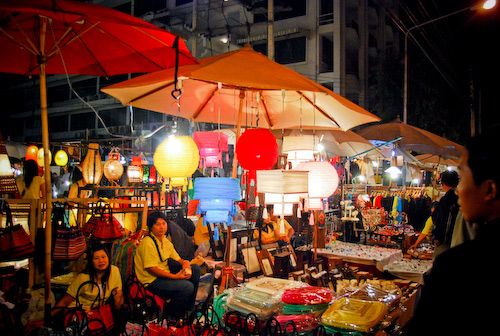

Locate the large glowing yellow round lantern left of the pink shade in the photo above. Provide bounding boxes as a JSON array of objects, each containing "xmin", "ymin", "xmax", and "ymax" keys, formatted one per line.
[{"xmin": 153, "ymin": 136, "xmax": 200, "ymax": 178}]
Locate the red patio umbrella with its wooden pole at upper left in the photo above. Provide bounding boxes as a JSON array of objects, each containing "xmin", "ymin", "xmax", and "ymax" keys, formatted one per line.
[{"xmin": 0, "ymin": 0, "xmax": 196, "ymax": 320}]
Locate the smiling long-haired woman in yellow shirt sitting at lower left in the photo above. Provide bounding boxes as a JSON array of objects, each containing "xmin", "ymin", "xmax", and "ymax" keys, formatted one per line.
[{"xmin": 52, "ymin": 244, "xmax": 123, "ymax": 325}]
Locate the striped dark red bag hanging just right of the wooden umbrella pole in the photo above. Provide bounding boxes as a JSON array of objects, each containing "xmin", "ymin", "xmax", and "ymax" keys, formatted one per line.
[{"xmin": 52, "ymin": 205, "xmax": 87, "ymax": 261}]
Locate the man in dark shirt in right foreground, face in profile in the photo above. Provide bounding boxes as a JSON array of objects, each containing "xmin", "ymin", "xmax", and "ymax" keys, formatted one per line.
[{"xmin": 406, "ymin": 132, "xmax": 500, "ymax": 335}]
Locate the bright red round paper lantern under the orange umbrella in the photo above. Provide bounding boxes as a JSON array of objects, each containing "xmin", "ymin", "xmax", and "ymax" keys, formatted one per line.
[{"xmin": 236, "ymin": 128, "xmax": 278, "ymax": 170}]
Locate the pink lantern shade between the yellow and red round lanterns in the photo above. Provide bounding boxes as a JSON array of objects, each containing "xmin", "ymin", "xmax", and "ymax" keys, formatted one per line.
[{"xmin": 193, "ymin": 132, "xmax": 228, "ymax": 168}]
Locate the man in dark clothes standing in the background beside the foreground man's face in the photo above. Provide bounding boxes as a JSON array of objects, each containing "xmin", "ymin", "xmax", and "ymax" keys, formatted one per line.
[{"xmin": 432, "ymin": 170, "xmax": 458, "ymax": 256}]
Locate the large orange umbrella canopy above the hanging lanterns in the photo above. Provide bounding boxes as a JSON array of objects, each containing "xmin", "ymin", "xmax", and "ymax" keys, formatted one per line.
[{"xmin": 102, "ymin": 47, "xmax": 380, "ymax": 131}]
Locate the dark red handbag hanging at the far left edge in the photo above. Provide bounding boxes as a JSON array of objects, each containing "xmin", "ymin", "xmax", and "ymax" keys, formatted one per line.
[{"xmin": 0, "ymin": 201, "xmax": 35, "ymax": 261}]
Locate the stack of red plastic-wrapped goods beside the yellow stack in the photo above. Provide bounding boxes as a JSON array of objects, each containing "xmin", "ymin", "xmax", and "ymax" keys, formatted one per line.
[{"xmin": 281, "ymin": 286, "xmax": 333, "ymax": 316}]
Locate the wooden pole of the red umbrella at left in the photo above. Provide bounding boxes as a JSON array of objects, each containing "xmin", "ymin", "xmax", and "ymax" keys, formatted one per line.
[{"xmin": 40, "ymin": 19, "xmax": 52, "ymax": 325}]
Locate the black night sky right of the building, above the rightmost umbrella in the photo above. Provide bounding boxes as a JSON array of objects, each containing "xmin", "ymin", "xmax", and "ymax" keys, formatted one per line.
[{"xmin": 401, "ymin": 0, "xmax": 500, "ymax": 142}]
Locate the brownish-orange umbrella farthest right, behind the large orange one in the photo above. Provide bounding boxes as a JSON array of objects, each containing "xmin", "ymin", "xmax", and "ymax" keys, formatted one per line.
[{"xmin": 357, "ymin": 120, "xmax": 463, "ymax": 158}]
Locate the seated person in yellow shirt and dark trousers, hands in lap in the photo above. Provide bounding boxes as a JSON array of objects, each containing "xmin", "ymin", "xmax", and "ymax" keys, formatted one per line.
[{"xmin": 134, "ymin": 211, "xmax": 200, "ymax": 318}]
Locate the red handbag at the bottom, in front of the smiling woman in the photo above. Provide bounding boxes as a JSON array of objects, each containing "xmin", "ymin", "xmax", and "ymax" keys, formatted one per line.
[{"xmin": 65, "ymin": 280, "xmax": 115, "ymax": 335}]
